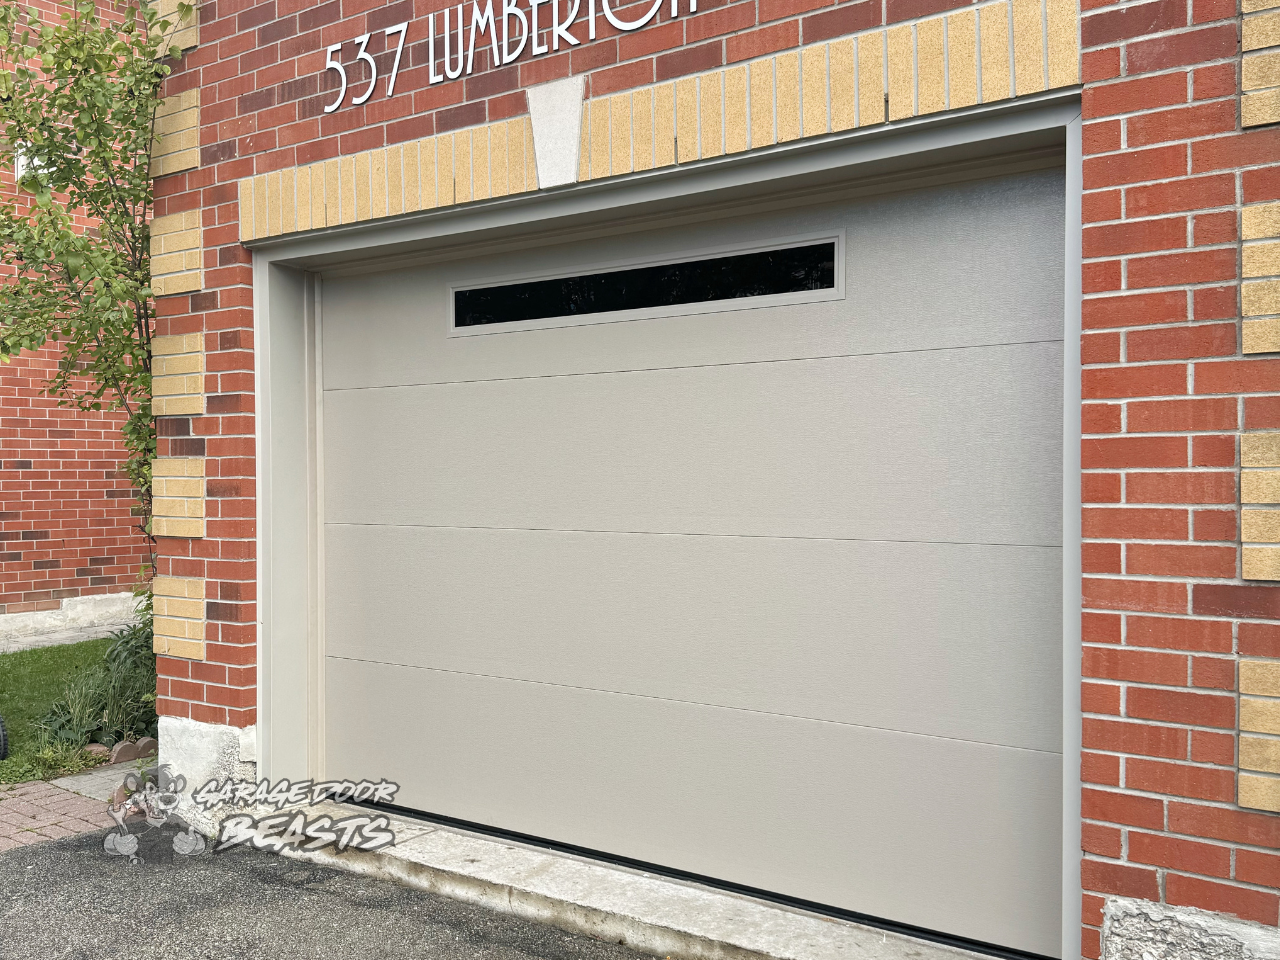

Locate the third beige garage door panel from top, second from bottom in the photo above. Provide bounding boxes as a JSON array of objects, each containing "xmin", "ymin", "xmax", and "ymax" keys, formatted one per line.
[{"xmin": 326, "ymin": 525, "xmax": 1062, "ymax": 751}]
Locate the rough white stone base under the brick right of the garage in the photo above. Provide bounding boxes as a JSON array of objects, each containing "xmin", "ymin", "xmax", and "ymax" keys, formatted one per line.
[{"xmin": 1102, "ymin": 897, "xmax": 1280, "ymax": 960}]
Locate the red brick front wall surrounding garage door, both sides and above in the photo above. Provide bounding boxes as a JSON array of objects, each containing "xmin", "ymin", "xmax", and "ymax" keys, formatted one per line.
[{"xmin": 157, "ymin": 0, "xmax": 1280, "ymax": 957}]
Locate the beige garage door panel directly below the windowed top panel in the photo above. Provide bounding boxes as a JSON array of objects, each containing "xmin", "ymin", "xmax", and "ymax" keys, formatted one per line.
[{"xmin": 325, "ymin": 343, "xmax": 1062, "ymax": 547}]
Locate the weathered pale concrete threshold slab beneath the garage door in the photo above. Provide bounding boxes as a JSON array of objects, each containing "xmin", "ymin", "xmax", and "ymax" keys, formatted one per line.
[{"xmin": 287, "ymin": 804, "xmax": 986, "ymax": 960}]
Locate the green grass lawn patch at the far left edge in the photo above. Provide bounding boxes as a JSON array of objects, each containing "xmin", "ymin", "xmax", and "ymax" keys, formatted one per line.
[{"xmin": 0, "ymin": 639, "xmax": 110, "ymax": 783}]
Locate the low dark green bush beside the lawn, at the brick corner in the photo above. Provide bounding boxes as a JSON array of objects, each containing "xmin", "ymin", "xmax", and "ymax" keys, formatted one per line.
[{"xmin": 38, "ymin": 617, "xmax": 157, "ymax": 748}]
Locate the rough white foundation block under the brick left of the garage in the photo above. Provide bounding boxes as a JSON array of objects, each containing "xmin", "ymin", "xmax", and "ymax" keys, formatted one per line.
[{"xmin": 159, "ymin": 717, "xmax": 257, "ymax": 836}]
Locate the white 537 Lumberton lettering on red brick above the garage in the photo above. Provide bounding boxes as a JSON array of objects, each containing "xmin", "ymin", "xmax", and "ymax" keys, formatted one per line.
[{"xmin": 324, "ymin": 0, "xmax": 698, "ymax": 114}]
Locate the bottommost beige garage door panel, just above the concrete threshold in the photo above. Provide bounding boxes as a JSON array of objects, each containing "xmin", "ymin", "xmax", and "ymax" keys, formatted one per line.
[{"xmin": 328, "ymin": 660, "xmax": 1061, "ymax": 951}]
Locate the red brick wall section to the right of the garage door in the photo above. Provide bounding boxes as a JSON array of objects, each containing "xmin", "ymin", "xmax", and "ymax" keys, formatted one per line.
[{"xmin": 1082, "ymin": 0, "xmax": 1280, "ymax": 957}]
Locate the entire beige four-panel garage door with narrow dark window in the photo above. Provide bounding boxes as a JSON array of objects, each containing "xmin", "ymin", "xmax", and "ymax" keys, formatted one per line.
[{"xmin": 321, "ymin": 170, "xmax": 1064, "ymax": 955}]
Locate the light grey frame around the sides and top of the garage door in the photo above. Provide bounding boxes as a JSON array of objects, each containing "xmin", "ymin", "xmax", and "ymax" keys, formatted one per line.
[{"xmin": 248, "ymin": 91, "xmax": 1082, "ymax": 956}]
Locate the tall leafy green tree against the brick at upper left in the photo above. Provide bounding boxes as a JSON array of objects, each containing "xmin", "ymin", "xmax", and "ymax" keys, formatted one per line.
[{"xmin": 0, "ymin": 0, "xmax": 192, "ymax": 545}]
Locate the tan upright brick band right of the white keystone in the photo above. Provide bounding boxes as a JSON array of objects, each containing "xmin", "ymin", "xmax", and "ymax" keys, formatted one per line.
[{"xmin": 579, "ymin": 0, "xmax": 1079, "ymax": 180}]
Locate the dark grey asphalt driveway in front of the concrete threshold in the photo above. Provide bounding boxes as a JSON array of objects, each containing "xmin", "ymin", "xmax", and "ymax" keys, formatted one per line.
[{"xmin": 0, "ymin": 828, "xmax": 641, "ymax": 960}]
